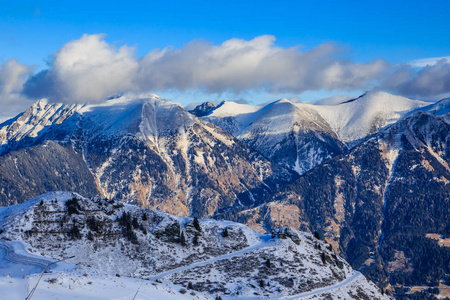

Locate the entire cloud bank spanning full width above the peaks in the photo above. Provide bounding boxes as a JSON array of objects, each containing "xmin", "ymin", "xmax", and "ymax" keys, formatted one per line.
[{"xmin": 0, "ymin": 34, "xmax": 450, "ymax": 120}]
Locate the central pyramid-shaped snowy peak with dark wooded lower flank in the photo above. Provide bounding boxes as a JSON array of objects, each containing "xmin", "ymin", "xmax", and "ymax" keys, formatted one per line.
[{"xmin": 204, "ymin": 99, "xmax": 346, "ymax": 180}]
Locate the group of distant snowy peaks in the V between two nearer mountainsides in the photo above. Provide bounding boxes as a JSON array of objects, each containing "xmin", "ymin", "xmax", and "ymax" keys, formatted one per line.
[{"xmin": 191, "ymin": 92, "xmax": 429, "ymax": 178}]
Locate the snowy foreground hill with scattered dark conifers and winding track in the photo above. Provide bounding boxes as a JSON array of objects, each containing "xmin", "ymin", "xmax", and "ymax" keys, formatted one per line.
[{"xmin": 0, "ymin": 192, "xmax": 390, "ymax": 299}]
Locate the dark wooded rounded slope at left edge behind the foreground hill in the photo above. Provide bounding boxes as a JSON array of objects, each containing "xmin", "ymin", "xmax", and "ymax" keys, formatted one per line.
[{"xmin": 0, "ymin": 141, "xmax": 102, "ymax": 206}]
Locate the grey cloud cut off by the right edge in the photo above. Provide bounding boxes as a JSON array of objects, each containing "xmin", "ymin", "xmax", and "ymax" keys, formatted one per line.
[{"xmin": 382, "ymin": 58, "xmax": 450, "ymax": 99}]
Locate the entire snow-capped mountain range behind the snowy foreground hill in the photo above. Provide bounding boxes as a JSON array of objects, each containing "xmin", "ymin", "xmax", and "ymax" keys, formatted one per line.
[{"xmin": 0, "ymin": 92, "xmax": 450, "ymax": 299}]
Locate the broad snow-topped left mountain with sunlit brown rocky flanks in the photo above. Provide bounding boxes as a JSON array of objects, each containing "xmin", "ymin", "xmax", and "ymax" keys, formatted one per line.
[{"xmin": 0, "ymin": 95, "xmax": 271, "ymax": 216}]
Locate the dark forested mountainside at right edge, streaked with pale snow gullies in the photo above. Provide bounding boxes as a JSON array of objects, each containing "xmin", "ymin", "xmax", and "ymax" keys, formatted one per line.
[{"xmin": 225, "ymin": 112, "xmax": 450, "ymax": 293}]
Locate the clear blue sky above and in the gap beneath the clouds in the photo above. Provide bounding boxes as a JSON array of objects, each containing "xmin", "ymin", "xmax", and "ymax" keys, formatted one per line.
[{"xmin": 0, "ymin": 0, "xmax": 450, "ymax": 118}]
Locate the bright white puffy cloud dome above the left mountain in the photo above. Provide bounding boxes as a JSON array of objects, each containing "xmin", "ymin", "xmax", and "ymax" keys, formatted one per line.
[{"xmin": 24, "ymin": 34, "xmax": 138, "ymax": 102}]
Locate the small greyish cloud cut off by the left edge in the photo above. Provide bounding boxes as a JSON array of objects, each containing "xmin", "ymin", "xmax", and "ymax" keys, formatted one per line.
[{"xmin": 0, "ymin": 59, "xmax": 33, "ymax": 122}]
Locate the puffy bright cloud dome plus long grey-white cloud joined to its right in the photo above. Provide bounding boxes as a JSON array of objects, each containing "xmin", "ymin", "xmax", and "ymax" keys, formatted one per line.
[{"xmin": 24, "ymin": 34, "xmax": 388, "ymax": 102}]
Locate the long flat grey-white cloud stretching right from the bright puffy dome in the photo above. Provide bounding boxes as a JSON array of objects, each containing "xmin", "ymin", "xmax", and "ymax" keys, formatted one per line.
[{"xmin": 138, "ymin": 35, "xmax": 387, "ymax": 93}]
